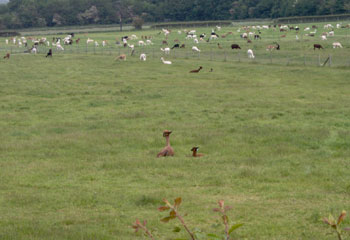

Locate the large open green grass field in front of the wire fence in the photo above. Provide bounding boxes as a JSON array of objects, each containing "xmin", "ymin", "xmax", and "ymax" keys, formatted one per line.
[{"xmin": 0, "ymin": 23, "xmax": 350, "ymax": 240}]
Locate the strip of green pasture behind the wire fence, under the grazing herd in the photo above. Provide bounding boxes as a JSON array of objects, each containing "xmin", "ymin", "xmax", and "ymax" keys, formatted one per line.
[{"xmin": 0, "ymin": 23, "xmax": 350, "ymax": 67}]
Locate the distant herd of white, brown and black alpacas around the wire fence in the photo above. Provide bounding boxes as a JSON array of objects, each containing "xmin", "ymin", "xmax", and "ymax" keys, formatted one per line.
[{"xmin": 4, "ymin": 23, "xmax": 350, "ymax": 64}]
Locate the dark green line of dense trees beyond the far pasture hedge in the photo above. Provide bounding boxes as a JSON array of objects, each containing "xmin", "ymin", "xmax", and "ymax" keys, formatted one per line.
[{"xmin": 0, "ymin": 0, "xmax": 350, "ymax": 29}]
